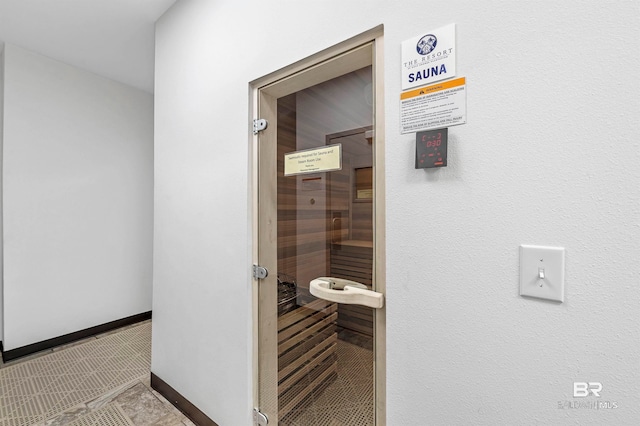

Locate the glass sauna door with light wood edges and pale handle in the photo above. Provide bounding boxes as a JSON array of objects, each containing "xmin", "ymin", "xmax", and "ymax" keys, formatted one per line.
[{"xmin": 255, "ymin": 38, "xmax": 384, "ymax": 426}]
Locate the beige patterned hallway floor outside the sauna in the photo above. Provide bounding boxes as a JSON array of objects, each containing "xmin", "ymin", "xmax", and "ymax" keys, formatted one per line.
[{"xmin": 0, "ymin": 321, "xmax": 193, "ymax": 426}]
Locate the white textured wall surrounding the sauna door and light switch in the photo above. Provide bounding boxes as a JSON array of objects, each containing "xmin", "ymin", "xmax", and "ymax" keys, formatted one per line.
[{"xmin": 153, "ymin": 0, "xmax": 640, "ymax": 425}]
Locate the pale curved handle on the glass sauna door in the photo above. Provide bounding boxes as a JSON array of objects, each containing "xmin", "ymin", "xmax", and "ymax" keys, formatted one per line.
[{"xmin": 309, "ymin": 277, "xmax": 384, "ymax": 309}]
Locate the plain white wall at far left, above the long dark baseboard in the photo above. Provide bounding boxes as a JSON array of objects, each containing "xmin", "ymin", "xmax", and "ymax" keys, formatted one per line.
[{"xmin": 3, "ymin": 44, "xmax": 153, "ymax": 350}]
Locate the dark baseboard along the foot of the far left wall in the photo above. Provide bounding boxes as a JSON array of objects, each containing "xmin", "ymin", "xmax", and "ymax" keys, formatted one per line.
[{"xmin": 2, "ymin": 311, "xmax": 151, "ymax": 362}]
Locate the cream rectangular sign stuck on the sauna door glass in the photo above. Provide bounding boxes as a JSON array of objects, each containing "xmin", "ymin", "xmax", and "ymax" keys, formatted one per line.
[{"xmin": 284, "ymin": 144, "xmax": 342, "ymax": 176}]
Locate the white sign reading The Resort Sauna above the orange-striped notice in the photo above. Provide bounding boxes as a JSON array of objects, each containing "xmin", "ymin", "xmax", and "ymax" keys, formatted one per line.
[{"xmin": 402, "ymin": 24, "xmax": 456, "ymax": 90}]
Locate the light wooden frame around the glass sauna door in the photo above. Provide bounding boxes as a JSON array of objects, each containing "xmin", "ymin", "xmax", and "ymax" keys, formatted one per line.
[{"xmin": 249, "ymin": 25, "xmax": 386, "ymax": 426}]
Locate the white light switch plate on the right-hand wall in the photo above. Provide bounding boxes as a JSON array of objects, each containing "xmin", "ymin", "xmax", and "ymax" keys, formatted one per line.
[{"xmin": 520, "ymin": 244, "xmax": 564, "ymax": 302}]
